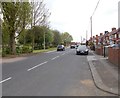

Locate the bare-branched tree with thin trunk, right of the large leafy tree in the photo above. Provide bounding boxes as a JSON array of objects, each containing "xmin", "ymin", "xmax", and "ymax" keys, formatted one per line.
[{"xmin": 31, "ymin": 0, "xmax": 50, "ymax": 50}]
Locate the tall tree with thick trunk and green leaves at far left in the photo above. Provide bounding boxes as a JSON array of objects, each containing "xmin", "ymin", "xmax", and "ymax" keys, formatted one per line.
[{"xmin": 1, "ymin": 2, "xmax": 31, "ymax": 54}]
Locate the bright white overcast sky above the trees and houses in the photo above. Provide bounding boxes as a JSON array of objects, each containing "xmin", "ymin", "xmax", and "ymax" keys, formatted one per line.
[{"xmin": 44, "ymin": 0, "xmax": 120, "ymax": 42}]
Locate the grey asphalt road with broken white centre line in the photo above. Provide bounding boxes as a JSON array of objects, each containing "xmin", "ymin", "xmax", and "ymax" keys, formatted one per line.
[{"xmin": 0, "ymin": 48, "xmax": 114, "ymax": 96}]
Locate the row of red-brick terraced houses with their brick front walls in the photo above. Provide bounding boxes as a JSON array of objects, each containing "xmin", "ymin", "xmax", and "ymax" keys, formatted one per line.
[{"xmin": 89, "ymin": 28, "xmax": 120, "ymax": 66}]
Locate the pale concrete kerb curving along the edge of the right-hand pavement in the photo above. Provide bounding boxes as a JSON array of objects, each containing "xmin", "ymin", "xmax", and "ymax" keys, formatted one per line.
[{"xmin": 87, "ymin": 56, "xmax": 119, "ymax": 95}]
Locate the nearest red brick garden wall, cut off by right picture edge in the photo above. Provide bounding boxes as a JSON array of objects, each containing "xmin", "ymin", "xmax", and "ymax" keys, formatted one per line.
[{"xmin": 108, "ymin": 48, "xmax": 120, "ymax": 68}]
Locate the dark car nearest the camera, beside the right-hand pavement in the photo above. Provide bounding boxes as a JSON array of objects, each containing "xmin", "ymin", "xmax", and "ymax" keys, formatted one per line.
[{"xmin": 76, "ymin": 45, "xmax": 89, "ymax": 55}]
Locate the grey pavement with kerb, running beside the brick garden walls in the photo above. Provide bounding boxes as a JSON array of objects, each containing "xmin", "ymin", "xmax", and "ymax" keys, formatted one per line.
[{"xmin": 87, "ymin": 51, "xmax": 120, "ymax": 95}]
